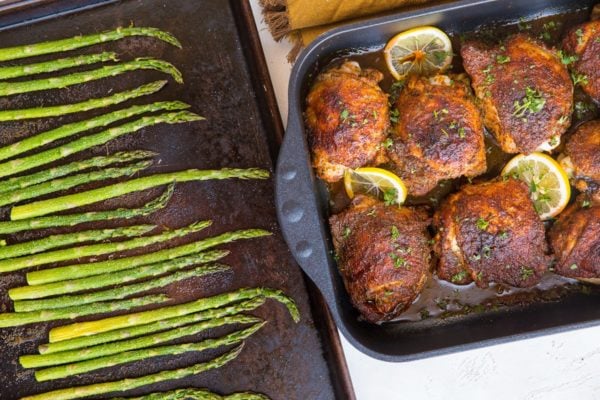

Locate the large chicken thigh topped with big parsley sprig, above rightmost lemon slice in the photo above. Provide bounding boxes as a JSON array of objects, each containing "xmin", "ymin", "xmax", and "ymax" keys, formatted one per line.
[{"xmin": 461, "ymin": 34, "xmax": 573, "ymax": 154}]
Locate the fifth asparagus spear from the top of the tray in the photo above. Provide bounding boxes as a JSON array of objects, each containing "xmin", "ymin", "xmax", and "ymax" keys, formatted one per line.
[{"xmin": 0, "ymin": 101, "xmax": 189, "ymax": 160}]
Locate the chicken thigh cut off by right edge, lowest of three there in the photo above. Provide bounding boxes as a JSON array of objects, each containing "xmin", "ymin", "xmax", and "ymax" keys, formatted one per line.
[{"xmin": 549, "ymin": 194, "xmax": 600, "ymax": 283}]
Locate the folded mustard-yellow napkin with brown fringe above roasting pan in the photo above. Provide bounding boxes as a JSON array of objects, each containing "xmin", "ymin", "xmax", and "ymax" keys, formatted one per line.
[{"xmin": 260, "ymin": 0, "xmax": 434, "ymax": 61}]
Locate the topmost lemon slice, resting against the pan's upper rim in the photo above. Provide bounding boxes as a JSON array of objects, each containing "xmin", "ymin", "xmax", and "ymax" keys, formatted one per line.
[{"xmin": 383, "ymin": 26, "xmax": 452, "ymax": 80}]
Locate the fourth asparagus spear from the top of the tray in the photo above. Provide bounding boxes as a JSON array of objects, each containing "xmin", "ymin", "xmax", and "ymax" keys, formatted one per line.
[{"xmin": 0, "ymin": 81, "xmax": 167, "ymax": 121}]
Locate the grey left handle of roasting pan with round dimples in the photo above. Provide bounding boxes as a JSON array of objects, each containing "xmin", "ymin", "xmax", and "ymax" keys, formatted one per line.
[{"xmin": 275, "ymin": 118, "xmax": 336, "ymax": 308}]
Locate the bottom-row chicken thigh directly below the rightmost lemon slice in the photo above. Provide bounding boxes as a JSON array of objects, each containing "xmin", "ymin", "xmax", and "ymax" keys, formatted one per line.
[{"xmin": 433, "ymin": 179, "xmax": 550, "ymax": 287}]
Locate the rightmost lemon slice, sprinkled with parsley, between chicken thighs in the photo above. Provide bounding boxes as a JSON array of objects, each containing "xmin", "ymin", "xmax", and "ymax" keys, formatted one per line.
[{"xmin": 502, "ymin": 153, "xmax": 571, "ymax": 220}]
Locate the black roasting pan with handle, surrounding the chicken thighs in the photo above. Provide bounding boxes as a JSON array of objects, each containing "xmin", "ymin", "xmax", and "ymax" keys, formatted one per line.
[{"xmin": 276, "ymin": 0, "xmax": 600, "ymax": 362}]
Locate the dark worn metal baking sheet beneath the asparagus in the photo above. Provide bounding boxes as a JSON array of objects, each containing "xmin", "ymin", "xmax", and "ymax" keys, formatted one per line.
[{"xmin": 0, "ymin": 0, "xmax": 353, "ymax": 400}]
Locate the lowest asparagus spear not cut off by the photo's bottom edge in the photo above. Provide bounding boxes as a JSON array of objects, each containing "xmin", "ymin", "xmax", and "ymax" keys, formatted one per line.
[{"xmin": 35, "ymin": 318, "xmax": 266, "ymax": 382}]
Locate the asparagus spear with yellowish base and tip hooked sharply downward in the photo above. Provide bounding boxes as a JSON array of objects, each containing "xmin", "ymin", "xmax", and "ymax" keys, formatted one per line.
[{"xmin": 49, "ymin": 288, "xmax": 300, "ymax": 343}]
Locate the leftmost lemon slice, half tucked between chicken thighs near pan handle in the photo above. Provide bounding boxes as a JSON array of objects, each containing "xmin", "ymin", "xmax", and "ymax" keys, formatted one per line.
[{"xmin": 344, "ymin": 167, "xmax": 407, "ymax": 205}]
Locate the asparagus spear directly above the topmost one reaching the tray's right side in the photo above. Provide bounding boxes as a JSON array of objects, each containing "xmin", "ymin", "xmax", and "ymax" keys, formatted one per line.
[{"xmin": 0, "ymin": 160, "xmax": 152, "ymax": 206}]
